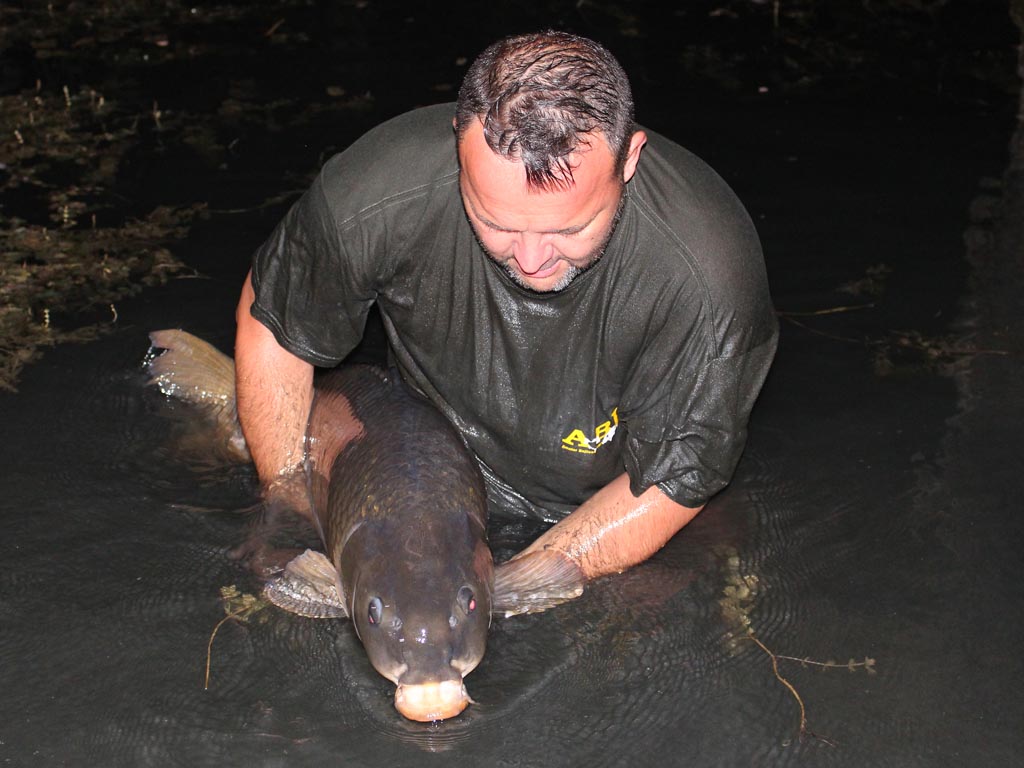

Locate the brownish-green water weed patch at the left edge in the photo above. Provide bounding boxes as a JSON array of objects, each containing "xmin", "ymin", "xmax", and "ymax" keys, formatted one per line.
[{"xmin": 0, "ymin": 85, "xmax": 195, "ymax": 390}]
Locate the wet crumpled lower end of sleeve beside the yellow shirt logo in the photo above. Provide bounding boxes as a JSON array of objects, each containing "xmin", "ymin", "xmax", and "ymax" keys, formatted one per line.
[{"xmin": 624, "ymin": 321, "xmax": 777, "ymax": 507}]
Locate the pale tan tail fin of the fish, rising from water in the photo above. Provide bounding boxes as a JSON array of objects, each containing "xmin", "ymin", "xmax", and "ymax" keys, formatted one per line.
[{"xmin": 147, "ymin": 329, "xmax": 249, "ymax": 461}]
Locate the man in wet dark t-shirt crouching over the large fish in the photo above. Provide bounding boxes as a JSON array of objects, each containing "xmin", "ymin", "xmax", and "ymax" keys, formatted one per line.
[{"xmin": 236, "ymin": 32, "xmax": 777, "ymax": 578}]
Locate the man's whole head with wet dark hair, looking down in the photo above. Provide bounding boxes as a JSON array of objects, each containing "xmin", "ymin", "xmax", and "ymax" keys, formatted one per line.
[{"xmin": 455, "ymin": 32, "xmax": 646, "ymax": 291}]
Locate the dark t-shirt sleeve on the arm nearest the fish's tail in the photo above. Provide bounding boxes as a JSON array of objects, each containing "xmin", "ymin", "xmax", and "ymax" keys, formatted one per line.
[{"xmin": 251, "ymin": 164, "xmax": 376, "ymax": 367}]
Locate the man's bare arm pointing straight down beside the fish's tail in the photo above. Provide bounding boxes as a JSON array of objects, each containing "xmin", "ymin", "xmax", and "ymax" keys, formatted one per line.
[{"xmin": 234, "ymin": 272, "xmax": 313, "ymax": 488}]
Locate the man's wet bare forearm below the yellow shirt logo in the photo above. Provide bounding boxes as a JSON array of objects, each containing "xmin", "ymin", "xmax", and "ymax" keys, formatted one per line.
[{"xmin": 522, "ymin": 473, "xmax": 703, "ymax": 580}]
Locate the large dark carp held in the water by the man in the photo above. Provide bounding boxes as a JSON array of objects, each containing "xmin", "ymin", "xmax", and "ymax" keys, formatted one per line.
[{"xmin": 148, "ymin": 330, "xmax": 584, "ymax": 721}]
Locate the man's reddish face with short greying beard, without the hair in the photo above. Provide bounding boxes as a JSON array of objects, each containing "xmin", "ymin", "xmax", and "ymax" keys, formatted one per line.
[{"xmin": 459, "ymin": 121, "xmax": 642, "ymax": 292}]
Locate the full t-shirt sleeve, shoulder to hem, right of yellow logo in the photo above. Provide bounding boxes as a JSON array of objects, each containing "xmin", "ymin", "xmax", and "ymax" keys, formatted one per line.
[{"xmin": 621, "ymin": 136, "xmax": 778, "ymax": 507}]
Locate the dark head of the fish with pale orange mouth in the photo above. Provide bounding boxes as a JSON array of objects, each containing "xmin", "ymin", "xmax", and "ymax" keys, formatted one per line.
[{"xmin": 342, "ymin": 530, "xmax": 494, "ymax": 721}]
